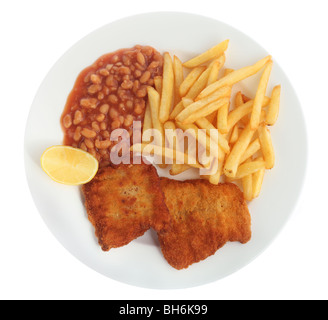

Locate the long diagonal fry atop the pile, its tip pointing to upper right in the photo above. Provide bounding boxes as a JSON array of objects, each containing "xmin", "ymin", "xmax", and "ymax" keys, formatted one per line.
[{"xmin": 196, "ymin": 56, "xmax": 271, "ymax": 100}]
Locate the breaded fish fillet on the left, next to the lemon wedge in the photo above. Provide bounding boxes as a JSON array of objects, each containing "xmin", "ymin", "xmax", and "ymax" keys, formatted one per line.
[{"xmin": 82, "ymin": 163, "xmax": 169, "ymax": 251}]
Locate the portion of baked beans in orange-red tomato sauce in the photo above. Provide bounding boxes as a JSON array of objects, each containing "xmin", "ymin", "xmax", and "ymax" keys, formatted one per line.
[{"xmin": 62, "ymin": 46, "xmax": 163, "ymax": 167}]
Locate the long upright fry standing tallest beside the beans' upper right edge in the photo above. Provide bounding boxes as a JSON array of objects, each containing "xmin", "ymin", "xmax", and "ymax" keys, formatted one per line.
[{"xmin": 159, "ymin": 52, "xmax": 174, "ymax": 123}]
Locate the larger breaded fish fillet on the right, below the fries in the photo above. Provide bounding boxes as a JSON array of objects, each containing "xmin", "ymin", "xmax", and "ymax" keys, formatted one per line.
[{"xmin": 158, "ymin": 178, "xmax": 251, "ymax": 269}]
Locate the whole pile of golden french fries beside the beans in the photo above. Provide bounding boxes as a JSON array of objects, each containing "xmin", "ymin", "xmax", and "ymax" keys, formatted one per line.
[{"xmin": 132, "ymin": 40, "xmax": 281, "ymax": 201}]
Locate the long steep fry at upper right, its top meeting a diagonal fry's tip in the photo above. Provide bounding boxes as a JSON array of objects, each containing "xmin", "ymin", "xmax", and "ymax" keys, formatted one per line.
[{"xmin": 250, "ymin": 61, "xmax": 273, "ymax": 130}]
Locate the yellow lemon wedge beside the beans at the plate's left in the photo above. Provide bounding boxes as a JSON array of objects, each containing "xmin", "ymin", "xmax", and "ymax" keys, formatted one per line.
[{"xmin": 41, "ymin": 146, "xmax": 99, "ymax": 186}]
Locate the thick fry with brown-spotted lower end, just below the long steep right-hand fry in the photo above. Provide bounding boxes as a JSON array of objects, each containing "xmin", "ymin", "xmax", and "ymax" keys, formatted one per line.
[{"xmin": 223, "ymin": 125, "xmax": 254, "ymax": 178}]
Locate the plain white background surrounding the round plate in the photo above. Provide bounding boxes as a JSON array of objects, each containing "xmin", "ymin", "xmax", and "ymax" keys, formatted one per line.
[{"xmin": 0, "ymin": 0, "xmax": 328, "ymax": 300}]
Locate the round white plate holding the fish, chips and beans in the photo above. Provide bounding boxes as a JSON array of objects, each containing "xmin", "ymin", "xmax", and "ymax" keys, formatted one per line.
[{"xmin": 25, "ymin": 12, "xmax": 307, "ymax": 289}]
